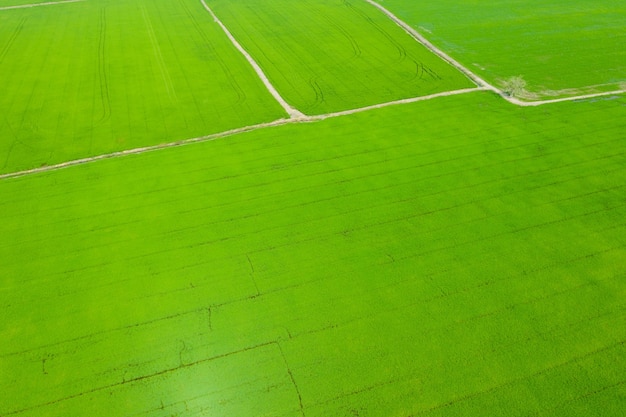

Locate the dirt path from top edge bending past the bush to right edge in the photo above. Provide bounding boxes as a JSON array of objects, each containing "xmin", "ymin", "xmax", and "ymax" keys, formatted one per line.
[{"xmin": 364, "ymin": 0, "xmax": 626, "ymax": 107}]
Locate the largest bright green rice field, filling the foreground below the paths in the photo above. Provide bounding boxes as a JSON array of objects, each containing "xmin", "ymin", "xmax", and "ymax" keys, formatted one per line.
[{"xmin": 0, "ymin": 92, "xmax": 626, "ymax": 417}]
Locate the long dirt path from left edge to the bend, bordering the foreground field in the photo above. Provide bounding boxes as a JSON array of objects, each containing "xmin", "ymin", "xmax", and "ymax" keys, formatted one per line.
[{"xmin": 0, "ymin": 88, "xmax": 488, "ymax": 180}]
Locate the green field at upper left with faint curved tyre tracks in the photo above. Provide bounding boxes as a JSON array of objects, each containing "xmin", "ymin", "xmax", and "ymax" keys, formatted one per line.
[{"xmin": 0, "ymin": 0, "xmax": 286, "ymax": 172}]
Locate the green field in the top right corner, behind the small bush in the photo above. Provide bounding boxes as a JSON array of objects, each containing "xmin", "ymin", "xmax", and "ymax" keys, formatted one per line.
[{"xmin": 380, "ymin": 0, "xmax": 626, "ymax": 98}]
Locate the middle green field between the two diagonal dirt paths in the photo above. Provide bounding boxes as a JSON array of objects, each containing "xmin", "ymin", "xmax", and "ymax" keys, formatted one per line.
[{"xmin": 207, "ymin": 0, "xmax": 473, "ymax": 114}]
